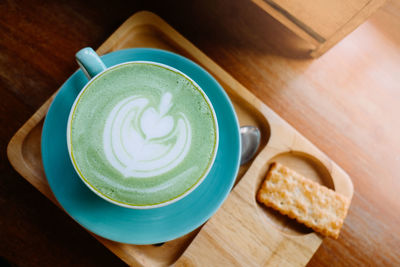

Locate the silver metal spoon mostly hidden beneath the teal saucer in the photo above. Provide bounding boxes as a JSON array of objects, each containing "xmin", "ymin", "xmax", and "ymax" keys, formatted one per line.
[{"xmin": 153, "ymin": 126, "xmax": 261, "ymax": 247}]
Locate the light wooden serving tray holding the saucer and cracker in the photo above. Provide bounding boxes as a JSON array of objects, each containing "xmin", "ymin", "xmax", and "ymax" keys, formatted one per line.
[{"xmin": 7, "ymin": 11, "xmax": 353, "ymax": 266}]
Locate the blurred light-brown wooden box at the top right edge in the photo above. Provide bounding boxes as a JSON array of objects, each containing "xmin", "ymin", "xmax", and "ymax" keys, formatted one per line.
[{"xmin": 252, "ymin": 0, "xmax": 385, "ymax": 57}]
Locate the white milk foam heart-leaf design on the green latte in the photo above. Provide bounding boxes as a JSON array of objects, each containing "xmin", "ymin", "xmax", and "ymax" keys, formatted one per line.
[{"xmin": 103, "ymin": 92, "xmax": 192, "ymax": 178}]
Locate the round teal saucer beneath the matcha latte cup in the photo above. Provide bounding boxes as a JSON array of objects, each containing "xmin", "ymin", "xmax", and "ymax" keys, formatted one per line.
[{"xmin": 42, "ymin": 48, "xmax": 240, "ymax": 244}]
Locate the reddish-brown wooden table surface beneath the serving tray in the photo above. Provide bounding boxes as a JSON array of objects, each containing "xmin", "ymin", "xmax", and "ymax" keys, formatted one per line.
[{"xmin": 0, "ymin": 0, "xmax": 400, "ymax": 266}]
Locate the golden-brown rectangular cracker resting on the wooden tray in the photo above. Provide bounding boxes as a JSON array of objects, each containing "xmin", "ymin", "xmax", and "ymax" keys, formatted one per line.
[{"xmin": 257, "ymin": 162, "xmax": 350, "ymax": 239}]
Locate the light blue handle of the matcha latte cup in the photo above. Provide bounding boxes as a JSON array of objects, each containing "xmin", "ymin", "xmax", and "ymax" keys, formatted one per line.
[{"xmin": 75, "ymin": 47, "xmax": 107, "ymax": 80}]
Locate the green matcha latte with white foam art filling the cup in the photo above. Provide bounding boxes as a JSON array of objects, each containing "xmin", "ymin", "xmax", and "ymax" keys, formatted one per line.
[{"xmin": 67, "ymin": 62, "xmax": 218, "ymax": 206}]
